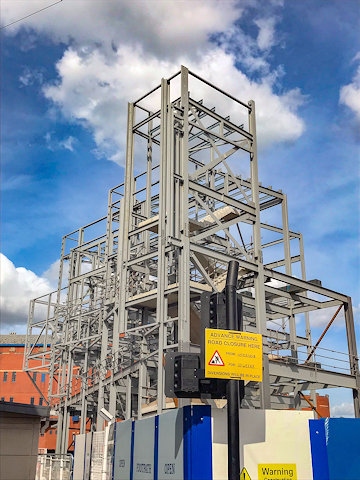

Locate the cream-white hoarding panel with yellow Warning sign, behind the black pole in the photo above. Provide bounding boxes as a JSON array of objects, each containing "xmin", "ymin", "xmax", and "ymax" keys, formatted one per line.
[{"xmin": 212, "ymin": 409, "xmax": 313, "ymax": 480}]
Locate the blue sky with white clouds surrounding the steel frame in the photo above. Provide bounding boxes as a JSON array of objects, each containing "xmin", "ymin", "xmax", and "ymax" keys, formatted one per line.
[{"xmin": 0, "ymin": 0, "xmax": 360, "ymax": 413}]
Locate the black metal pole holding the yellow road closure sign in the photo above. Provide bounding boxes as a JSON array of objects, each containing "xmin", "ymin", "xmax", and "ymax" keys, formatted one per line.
[{"xmin": 225, "ymin": 260, "xmax": 240, "ymax": 480}]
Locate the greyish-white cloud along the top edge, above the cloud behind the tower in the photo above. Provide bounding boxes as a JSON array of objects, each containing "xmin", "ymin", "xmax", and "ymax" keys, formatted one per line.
[{"xmin": 1, "ymin": 0, "xmax": 241, "ymax": 58}]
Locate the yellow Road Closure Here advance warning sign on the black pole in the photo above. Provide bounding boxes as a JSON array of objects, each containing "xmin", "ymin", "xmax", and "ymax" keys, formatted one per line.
[{"xmin": 205, "ymin": 328, "xmax": 262, "ymax": 382}]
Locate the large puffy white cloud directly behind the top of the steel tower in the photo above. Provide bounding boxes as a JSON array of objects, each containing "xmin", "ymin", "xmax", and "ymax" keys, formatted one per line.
[{"xmin": 44, "ymin": 46, "xmax": 305, "ymax": 163}]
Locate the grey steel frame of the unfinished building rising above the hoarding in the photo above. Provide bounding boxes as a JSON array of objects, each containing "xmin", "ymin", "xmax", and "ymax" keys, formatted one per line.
[{"xmin": 24, "ymin": 67, "xmax": 360, "ymax": 453}]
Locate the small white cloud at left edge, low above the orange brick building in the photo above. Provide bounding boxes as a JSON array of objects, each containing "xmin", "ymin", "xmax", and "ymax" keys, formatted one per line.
[{"xmin": 0, "ymin": 253, "xmax": 53, "ymax": 333}]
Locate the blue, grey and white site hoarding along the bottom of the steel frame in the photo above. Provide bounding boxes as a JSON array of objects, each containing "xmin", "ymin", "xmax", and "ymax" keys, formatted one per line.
[{"xmin": 72, "ymin": 406, "xmax": 360, "ymax": 480}]
